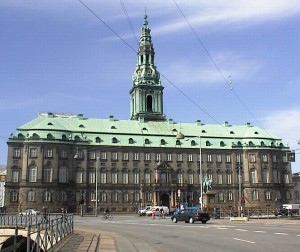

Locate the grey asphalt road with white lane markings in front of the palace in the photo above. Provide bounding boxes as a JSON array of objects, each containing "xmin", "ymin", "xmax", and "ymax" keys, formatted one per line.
[{"xmin": 75, "ymin": 215, "xmax": 300, "ymax": 252}]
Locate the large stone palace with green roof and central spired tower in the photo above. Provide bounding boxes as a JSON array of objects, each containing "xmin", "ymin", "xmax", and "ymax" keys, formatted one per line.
[{"xmin": 5, "ymin": 16, "xmax": 293, "ymax": 213}]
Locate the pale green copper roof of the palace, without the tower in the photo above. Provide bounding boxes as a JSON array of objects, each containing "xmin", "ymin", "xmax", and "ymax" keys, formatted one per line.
[{"xmin": 9, "ymin": 113, "xmax": 287, "ymax": 149}]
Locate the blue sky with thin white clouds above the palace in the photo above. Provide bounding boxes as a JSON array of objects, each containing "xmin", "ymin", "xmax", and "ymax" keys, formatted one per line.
[{"xmin": 0, "ymin": 0, "xmax": 300, "ymax": 172}]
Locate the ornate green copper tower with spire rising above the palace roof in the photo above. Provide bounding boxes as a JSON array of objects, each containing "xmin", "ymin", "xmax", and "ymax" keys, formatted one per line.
[{"xmin": 130, "ymin": 14, "xmax": 166, "ymax": 121}]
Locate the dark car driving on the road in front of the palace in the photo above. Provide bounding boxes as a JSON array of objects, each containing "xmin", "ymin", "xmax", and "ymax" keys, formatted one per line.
[{"xmin": 171, "ymin": 207, "xmax": 210, "ymax": 223}]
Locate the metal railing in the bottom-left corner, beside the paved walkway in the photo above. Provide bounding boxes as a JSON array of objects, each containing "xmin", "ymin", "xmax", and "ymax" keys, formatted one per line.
[{"xmin": 0, "ymin": 214, "xmax": 74, "ymax": 252}]
